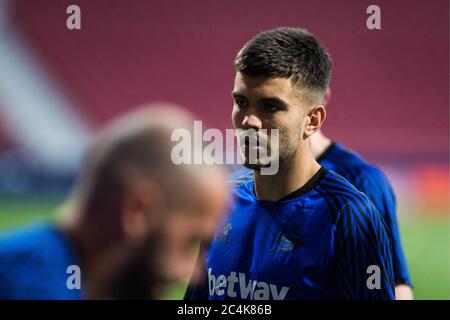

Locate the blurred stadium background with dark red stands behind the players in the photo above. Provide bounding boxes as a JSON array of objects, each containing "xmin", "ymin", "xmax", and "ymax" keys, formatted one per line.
[{"xmin": 0, "ymin": 0, "xmax": 450, "ymax": 299}]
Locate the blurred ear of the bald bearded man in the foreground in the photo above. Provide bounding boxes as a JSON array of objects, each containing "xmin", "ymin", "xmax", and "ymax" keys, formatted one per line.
[{"xmin": 121, "ymin": 178, "xmax": 162, "ymax": 239}]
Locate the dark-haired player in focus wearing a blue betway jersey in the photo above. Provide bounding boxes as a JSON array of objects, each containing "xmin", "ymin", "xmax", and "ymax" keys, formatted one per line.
[{"xmin": 186, "ymin": 28, "xmax": 394, "ymax": 299}]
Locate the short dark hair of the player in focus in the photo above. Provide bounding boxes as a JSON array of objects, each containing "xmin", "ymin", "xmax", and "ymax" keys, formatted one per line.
[{"xmin": 234, "ymin": 28, "xmax": 332, "ymax": 105}]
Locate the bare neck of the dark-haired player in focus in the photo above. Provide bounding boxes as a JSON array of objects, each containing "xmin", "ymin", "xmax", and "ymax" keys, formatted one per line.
[{"xmin": 254, "ymin": 146, "xmax": 320, "ymax": 201}]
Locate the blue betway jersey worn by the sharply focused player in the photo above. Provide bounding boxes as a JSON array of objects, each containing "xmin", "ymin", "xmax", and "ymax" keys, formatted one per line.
[{"xmin": 204, "ymin": 167, "xmax": 394, "ymax": 300}]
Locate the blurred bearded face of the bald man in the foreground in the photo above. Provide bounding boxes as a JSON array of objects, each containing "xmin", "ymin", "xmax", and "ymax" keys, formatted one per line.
[{"xmin": 108, "ymin": 170, "xmax": 228, "ymax": 299}]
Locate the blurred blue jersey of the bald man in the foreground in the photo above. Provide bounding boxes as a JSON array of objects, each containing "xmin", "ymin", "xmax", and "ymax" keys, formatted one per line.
[{"xmin": 0, "ymin": 223, "xmax": 82, "ymax": 300}]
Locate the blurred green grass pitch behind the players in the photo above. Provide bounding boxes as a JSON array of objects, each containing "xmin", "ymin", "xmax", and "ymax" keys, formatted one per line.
[{"xmin": 0, "ymin": 198, "xmax": 450, "ymax": 300}]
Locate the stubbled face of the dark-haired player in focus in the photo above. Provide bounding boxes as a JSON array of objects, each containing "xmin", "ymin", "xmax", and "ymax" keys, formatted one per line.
[{"xmin": 232, "ymin": 72, "xmax": 307, "ymax": 169}]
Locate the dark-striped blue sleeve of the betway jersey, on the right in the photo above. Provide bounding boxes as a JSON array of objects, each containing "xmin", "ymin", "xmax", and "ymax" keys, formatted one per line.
[{"xmin": 333, "ymin": 197, "xmax": 395, "ymax": 300}]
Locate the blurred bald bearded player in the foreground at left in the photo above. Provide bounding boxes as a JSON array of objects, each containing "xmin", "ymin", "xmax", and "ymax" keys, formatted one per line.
[{"xmin": 0, "ymin": 107, "xmax": 226, "ymax": 299}]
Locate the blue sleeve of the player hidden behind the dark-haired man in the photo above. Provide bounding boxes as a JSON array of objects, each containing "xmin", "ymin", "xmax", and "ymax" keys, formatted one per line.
[{"xmin": 355, "ymin": 168, "xmax": 412, "ymax": 287}]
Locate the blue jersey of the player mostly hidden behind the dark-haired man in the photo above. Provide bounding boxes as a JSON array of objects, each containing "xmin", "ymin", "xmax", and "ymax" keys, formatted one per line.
[{"xmin": 230, "ymin": 143, "xmax": 412, "ymax": 287}]
